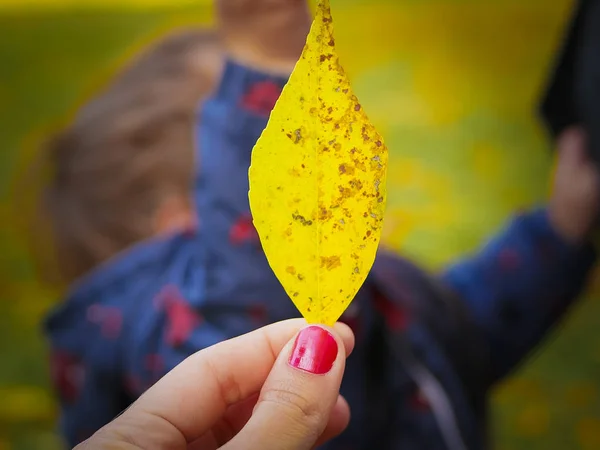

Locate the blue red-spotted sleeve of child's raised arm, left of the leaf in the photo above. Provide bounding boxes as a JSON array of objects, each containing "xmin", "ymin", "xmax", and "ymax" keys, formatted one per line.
[{"xmin": 195, "ymin": 61, "xmax": 287, "ymax": 247}]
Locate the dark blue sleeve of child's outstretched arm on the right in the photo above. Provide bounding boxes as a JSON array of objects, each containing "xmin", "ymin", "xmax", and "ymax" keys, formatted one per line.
[{"xmin": 443, "ymin": 209, "xmax": 596, "ymax": 381}]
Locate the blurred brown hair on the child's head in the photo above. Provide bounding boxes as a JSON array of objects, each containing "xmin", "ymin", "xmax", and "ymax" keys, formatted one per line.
[{"xmin": 40, "ymin": 30, "xmax": 220, "ymax": 282}]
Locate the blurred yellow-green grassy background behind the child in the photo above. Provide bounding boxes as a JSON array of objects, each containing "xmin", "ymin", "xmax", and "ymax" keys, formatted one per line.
[{"xmin": 0, "ymin": 0, "xmax": 600, "ymax": 450}]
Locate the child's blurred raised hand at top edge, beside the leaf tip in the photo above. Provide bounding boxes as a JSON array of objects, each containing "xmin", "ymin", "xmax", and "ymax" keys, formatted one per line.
[{"xmin": 216, "ymin": 0, "xmax": 312, "ymax": 75}]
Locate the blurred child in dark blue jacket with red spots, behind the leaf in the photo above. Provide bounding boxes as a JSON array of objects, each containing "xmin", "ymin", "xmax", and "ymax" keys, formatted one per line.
[{"xmin": 39, "ymin": 0, "xmax": 600, "ymax": 450}]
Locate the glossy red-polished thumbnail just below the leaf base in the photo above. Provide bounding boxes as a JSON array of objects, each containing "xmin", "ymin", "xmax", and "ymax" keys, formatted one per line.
[{"xmin": 289, "ymin": 326, "xmax": 338, "ymax": 375}]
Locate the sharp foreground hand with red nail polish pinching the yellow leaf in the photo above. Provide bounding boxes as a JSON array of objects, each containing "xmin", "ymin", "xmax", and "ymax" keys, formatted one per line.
[{"xmin": 76, "ymin": 320, "xmax": 354, "ymax": 450}]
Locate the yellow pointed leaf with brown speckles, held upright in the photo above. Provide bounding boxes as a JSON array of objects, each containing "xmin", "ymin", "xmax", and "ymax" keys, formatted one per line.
[{"xmin": 249, "ymin": 0, "xmax": 387, "ymax": 325}]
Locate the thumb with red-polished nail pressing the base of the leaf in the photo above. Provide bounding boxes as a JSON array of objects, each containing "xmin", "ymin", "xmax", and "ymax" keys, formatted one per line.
[{"xmin": 223, "ymin": 325, "xmax": 350, "ymax": 450}]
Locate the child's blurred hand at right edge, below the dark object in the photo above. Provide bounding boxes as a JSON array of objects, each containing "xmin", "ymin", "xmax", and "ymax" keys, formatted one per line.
[{"xmin": 549, "ymin": 127, "xmax": 600, "ymax": 243}]
